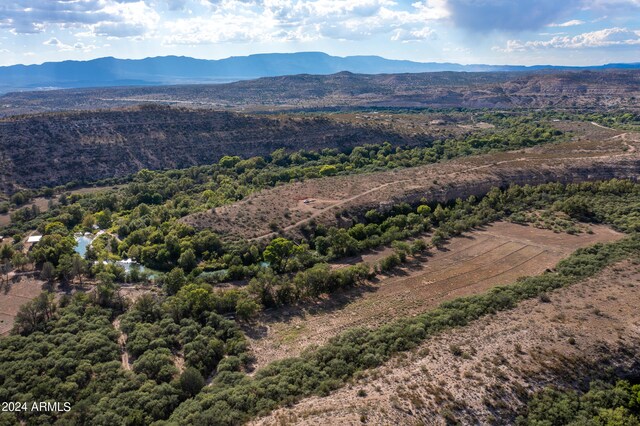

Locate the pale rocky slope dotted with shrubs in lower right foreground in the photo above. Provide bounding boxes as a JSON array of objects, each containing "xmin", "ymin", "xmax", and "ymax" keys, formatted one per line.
[{"xmin": 253, "ymin": 261, "xmax": 640, "ymax": 425}]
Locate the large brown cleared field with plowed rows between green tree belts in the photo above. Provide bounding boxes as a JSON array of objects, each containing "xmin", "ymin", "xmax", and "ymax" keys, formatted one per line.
[{"xmin": 248, "ymin": 222, "xmax": 622, "ymax": 366}]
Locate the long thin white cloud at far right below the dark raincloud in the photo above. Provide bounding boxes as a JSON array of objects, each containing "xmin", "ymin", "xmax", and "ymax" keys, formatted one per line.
[{"xmin": 494, "ymin": 27, "xmax": 640, "ymax": 52}]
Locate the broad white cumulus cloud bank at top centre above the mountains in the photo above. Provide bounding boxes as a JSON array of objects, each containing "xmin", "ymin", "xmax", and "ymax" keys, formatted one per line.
[{"xmin": 164, "ymin": 0, "xmax": 448, "ymax": 45}]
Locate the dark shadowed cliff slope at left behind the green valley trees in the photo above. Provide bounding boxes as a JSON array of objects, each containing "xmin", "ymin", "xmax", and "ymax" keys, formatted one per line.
[{"xmin": 0, "ymin": 107, "xmax": 430, "ymax": 192}]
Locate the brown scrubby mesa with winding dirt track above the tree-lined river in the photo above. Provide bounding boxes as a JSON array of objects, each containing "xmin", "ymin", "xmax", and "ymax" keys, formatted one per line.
[{"xmin": 182, "ymin": 122, "xmax": 640, "ymax": 239}]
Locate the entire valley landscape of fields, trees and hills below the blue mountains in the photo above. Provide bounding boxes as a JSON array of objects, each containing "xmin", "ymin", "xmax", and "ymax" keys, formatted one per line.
[{"xmin": 0, "ymin": 70, "xmax": 640, "ymax": 425}]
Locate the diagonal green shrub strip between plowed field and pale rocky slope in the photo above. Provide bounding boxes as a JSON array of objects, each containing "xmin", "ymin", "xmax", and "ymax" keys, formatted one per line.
[{"xmin": 170, "ymin": 235, "xmax": 640, "ymax": 424}]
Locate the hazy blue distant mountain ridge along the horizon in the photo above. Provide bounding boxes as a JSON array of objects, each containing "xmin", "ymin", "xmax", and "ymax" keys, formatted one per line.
[{"xmin": 0, "ymin": 52, "xmax": 640, "ymax": 93}]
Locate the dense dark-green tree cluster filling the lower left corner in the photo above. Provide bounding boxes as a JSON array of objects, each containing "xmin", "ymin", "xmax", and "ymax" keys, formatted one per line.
[{"xmin": 0, "ymin": 293, "xmax": 248, "ymax": 426}]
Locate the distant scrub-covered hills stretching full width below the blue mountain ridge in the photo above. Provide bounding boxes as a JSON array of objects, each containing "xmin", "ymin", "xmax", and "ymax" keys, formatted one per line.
[{"xmin": 0, "ymin": 70, "xmax": 640, "ymax": 116}]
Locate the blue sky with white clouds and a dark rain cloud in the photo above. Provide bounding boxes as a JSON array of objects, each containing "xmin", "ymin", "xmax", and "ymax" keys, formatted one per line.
[{"xmin": 0, "ymin": 0, "xmax": 640, "ymax": 65}]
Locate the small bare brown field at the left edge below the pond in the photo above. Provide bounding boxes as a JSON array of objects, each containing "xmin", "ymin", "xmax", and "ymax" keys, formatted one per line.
[{"xmin": 0, "ymin": 276, "xmax": 45, "ymax": 336}]
